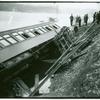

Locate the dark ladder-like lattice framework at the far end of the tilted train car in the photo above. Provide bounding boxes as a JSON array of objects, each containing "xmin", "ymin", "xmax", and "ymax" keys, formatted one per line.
[{"xmin": 54, "ymin": 26, "xmax": 72, "ymax": 54}]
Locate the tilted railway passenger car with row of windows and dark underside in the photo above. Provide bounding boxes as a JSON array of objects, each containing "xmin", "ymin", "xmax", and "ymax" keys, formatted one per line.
[{"xmin": 0, "ymin": 22, "xmax": 60, "ymax": 97}]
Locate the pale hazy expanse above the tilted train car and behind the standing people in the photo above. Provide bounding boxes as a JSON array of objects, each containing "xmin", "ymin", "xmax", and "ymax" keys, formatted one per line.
[{"xmin": 0, "ymin": 3, "xmax": 100, "ymax": 31}]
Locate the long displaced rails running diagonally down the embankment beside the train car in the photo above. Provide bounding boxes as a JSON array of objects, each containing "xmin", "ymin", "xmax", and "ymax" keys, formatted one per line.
[{"xmin": 29, "ymin": 23, "xmax": 98, "ymax": 97}]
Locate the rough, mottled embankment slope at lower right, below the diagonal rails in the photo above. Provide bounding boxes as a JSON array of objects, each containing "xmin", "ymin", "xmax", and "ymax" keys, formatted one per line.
[{"xmin": 41, "ymin": 24, "xmax": 100, "ymax": 97}]
